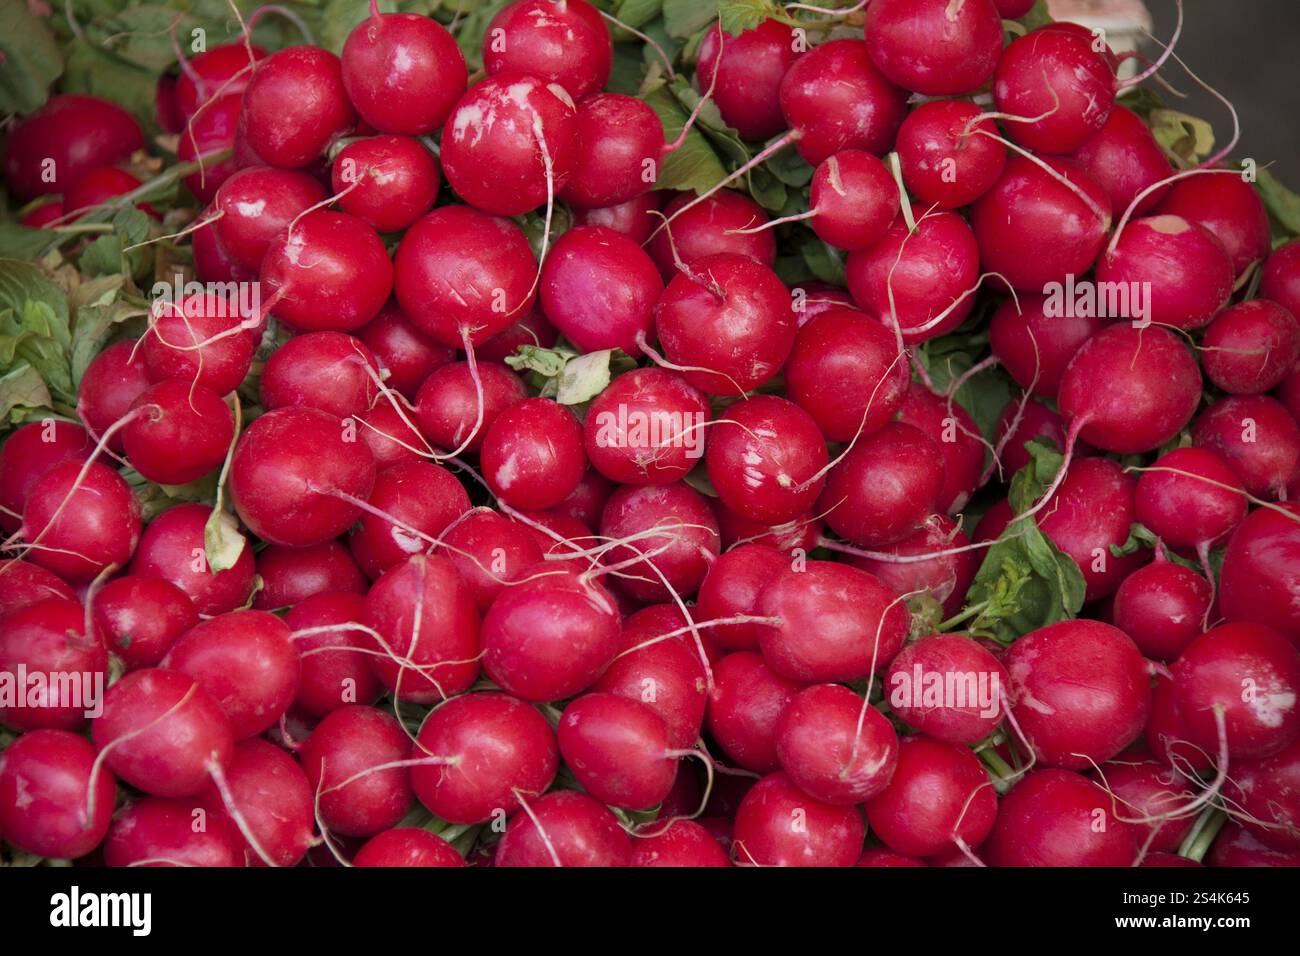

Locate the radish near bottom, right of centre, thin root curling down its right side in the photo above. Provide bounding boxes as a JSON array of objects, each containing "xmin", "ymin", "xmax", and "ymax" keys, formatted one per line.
[{"xmin": 866, "ymin": 735, "xmax": 997, "ymax": 857}]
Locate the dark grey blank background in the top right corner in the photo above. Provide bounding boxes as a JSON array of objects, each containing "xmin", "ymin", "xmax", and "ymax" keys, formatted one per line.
[{"xmin": 1144, "ymin": 0, "xmax": 1300, "ymax": 184}]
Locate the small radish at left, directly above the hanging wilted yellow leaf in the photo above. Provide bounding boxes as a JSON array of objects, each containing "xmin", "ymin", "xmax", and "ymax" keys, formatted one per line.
[{"xmin": 122, "ymin": 378, "xmax": 235, "ymax": 485}]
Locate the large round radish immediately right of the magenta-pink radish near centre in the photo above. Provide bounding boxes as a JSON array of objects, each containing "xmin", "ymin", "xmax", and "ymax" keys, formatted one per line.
[{"xmin": 655, "ymin": 254, "xmax": 794, "ymax": 395}]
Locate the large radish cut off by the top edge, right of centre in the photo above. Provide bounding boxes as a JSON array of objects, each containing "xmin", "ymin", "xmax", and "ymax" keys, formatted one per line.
[{"xmin": 866, "ymin": 0, "xmax": 1002, "ymax": 96}]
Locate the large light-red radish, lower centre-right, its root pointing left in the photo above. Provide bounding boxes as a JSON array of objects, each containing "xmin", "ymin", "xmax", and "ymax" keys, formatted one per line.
[{"xmin": 757, "ymin": 561, "xmax": 907, "ymax": 683}]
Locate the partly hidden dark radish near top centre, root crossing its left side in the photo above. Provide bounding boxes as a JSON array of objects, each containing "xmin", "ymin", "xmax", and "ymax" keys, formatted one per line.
[{"xmin": 696, "ymin": 18, "xmax": 801, "ymax": 140}]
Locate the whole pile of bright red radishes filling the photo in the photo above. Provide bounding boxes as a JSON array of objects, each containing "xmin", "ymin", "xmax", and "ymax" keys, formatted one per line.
[{"xmin": 0, "ymin": 0, "xmax": 1300, "ymax": 866}]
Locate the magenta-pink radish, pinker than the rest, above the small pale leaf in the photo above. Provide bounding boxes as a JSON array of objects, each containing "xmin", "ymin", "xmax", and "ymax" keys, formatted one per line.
[{"xmin": 541, "ymin": 226, "xmax": 663, "ymax": 355}]
